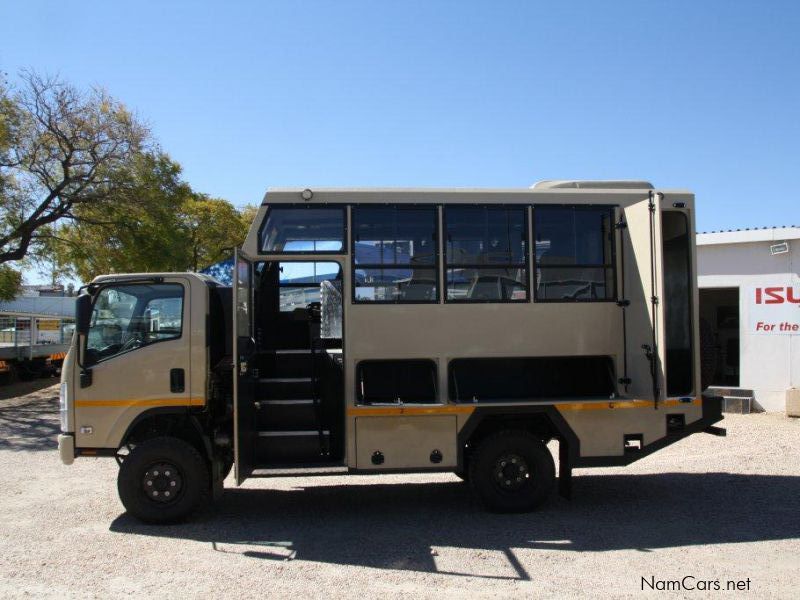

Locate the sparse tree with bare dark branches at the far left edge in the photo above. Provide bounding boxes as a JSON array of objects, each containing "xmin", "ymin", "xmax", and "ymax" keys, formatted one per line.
[{"xmin": 0, "ymin": 72, "xmax": 148, "ymax": 264}]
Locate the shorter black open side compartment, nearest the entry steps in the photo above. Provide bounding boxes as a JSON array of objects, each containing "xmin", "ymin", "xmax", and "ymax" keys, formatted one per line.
[{"xmin": 356, "ymin": 360, "xmax": 437, "ymax": 404}]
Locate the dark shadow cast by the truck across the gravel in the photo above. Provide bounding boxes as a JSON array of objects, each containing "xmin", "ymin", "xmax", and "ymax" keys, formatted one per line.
[{"xmin": 111, "ymin": 473, "xmax": 800, "ymax": 580}]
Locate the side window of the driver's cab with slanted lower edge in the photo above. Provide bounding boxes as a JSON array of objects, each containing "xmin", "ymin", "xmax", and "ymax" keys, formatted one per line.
[{"xmin": 86, "ymin": 283, "xmax": 183, "ymax": 364}]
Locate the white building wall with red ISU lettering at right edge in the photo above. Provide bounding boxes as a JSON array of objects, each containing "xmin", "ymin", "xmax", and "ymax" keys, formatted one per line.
[{"xmin": 697, "ymin": 239, "xmax": 800, "ymax": 411}]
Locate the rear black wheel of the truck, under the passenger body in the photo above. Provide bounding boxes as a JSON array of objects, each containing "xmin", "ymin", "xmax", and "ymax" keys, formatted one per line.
[{"xmin": 469, "ymin": 430, "xmax": 556, "ymax": 512}]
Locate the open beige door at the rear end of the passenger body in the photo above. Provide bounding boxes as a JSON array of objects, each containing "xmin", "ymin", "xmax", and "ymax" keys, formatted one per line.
[{"xmin": 622, "ymin": 193, "xmax": 664, "ymax": 401}]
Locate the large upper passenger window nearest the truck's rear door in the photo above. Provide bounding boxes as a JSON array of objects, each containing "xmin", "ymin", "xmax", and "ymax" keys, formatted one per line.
[{"xmin": 533, "ymin": 206, "xmax": 616, "ymax": 302}]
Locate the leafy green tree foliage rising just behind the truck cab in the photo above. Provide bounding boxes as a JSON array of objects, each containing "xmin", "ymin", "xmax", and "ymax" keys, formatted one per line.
[{"xmin": 57, "ymin": 152, "xmax": 251, "ymax": 281}]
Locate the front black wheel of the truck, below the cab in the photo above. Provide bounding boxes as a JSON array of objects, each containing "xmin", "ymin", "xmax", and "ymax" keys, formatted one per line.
[{"xmin": 117, "ymin": 437, "xmax": 210, "ymax": 523}]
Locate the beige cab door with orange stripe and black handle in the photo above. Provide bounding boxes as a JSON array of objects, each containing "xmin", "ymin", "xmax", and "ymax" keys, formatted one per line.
[{"xmin": 73, "ymin": 276, "xmax": 195, "ymax": 448}]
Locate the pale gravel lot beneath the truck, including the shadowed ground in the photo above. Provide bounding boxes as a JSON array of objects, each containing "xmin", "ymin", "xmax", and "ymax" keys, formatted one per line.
[{"xmin": 0, "ymin": 382, "xmax": 800, "ymax": 598}]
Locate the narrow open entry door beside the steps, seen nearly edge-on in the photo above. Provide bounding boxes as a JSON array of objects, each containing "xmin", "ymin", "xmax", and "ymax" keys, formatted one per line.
[{"xmin": 233, "ymin": 249, "xmax": 257, "ymax": 485}]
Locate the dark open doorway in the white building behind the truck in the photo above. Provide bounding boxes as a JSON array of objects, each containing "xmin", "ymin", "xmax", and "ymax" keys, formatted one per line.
[{"xmin": 700, "ymin": 287, "xmax": 741, "ymax": 387}]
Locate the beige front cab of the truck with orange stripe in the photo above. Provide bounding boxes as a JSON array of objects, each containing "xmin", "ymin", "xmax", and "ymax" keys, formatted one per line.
[{"xmin": 59, "ymin": 273, "xmax": 233, "ymax": 518}]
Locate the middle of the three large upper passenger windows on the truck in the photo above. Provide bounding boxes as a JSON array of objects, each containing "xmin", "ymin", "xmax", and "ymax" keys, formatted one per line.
[{"xmin": 445, "ymin": 206, "xmax": 528, "ymax": 302}]
